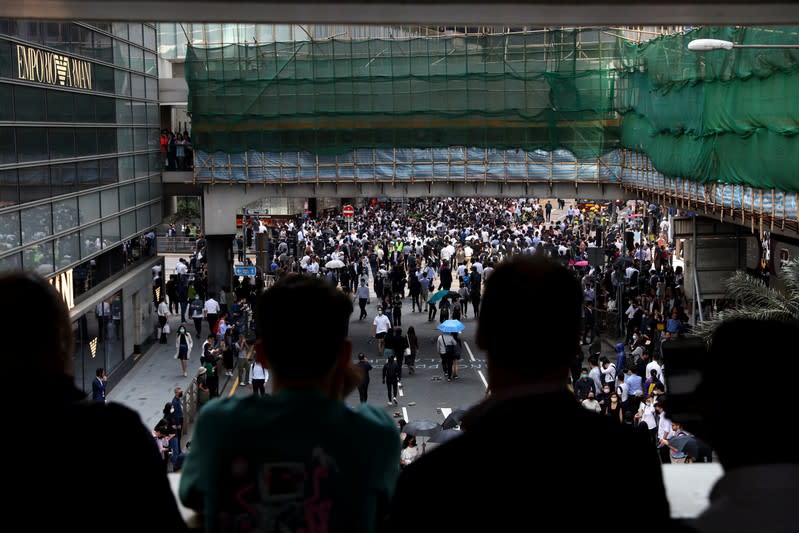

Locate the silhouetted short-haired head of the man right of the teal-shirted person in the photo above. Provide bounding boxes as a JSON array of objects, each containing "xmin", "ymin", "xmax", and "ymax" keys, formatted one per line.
[{"xmin": 477, "ymin": 256, "xmax": 583, "ymax": 382}]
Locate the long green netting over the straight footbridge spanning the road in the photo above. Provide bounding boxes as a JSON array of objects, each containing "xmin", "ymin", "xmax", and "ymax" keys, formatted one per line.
[{"xmin": 186, "ymin": 29, "xmax": 622, "ymax": 158}]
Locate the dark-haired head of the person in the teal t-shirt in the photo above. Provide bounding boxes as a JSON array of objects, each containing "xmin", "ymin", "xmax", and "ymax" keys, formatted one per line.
[{"xmin": 255, "ymin": 275, "xmax": 352, "ymax": 380}]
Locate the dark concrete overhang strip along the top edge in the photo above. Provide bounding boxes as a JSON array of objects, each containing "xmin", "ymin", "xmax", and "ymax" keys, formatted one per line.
[{"xmin": 0, "ymin": 0, "xmax": 799, "ymax": 26}]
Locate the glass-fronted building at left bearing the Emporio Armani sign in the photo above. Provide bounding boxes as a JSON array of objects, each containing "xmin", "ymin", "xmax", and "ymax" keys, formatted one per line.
[{"xmin": 0, "ymin": 20, "xmax": 162, "ymax": 391}]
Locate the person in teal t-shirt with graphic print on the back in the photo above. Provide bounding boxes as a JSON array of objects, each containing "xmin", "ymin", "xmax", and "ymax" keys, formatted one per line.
[{"xmin": 180, "ymin": 275, "xmax": 400, "ymax": 533}]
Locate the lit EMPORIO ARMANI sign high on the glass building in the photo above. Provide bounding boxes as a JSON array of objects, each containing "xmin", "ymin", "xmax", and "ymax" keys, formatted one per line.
[{"xmin": 17, "ymin": 44, "xmax": 94, "ymax": 89}]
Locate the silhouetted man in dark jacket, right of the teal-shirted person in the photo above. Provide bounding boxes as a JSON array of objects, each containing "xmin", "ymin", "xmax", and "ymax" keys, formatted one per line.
[{"xmin": 391, "ymin": 256, "xmax": 670, "ymax": 532}]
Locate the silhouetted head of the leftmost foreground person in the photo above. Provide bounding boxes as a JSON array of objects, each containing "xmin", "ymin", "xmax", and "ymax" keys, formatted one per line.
[{"xmin": 0, "ymin": 272, "xmax": 75, "ymax": 376}]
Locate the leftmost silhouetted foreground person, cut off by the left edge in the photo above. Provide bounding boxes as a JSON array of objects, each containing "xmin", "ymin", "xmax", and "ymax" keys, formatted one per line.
[{"xmin": 0, "ymin": 272, "xmax": 186, "ymax": 532}]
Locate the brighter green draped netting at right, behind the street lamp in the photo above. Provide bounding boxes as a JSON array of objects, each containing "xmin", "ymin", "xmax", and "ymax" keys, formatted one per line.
[{"xmin": 616, "ymin": 27, "xmax": 799, "ymax": 191}]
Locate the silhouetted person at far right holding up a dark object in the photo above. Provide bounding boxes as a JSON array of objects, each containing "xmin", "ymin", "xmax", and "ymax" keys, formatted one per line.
[{"xmin": 686, "ymin": 319, "xmax": 799, "ymax": 533}]
